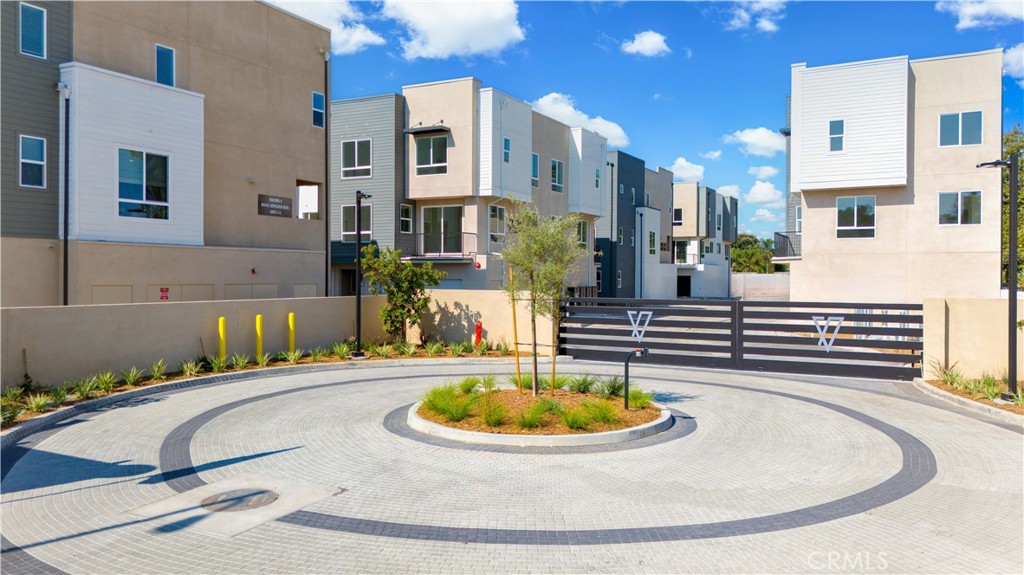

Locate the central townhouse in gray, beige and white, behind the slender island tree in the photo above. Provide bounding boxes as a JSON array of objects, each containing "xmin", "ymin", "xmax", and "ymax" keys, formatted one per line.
[{"xmin": 330, "ymin": 78, "xmax": 606, "ymax": 292}]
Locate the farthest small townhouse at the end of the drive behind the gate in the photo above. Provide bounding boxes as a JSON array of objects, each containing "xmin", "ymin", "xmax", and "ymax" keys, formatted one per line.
[{"xmin": 672, "ymin": 182, "xmax": 738, "ymax": 298}]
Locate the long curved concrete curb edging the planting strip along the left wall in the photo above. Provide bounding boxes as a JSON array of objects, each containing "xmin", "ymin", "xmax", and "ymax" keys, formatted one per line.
[{"xmin": 0, "ymin": 355, "xmax": 572, "ymax": 448}]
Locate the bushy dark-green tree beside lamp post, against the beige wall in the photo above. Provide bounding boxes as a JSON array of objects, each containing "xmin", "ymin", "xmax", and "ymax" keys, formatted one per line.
[{"xmin": 362, "ymin": 246, "xmax": 447, "ymax": 341}]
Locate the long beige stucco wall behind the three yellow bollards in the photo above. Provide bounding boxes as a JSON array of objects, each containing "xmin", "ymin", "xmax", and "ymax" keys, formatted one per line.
[{"xmin": 0, "ymin": 297, "xmax": 385, "ymax": 388}]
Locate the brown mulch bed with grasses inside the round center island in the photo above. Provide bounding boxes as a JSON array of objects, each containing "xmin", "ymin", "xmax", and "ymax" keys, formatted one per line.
[{"xmin": 417, "ymin": 389, "xmax": 662, "ymax": 435}]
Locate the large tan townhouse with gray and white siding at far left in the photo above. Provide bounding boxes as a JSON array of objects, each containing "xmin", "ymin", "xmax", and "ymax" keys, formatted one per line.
[{"xmin": 0, "ymin": 1, "xmax": 330, "ymax": 306}]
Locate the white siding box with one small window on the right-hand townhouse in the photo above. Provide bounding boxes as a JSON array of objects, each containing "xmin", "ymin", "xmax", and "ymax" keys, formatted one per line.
[{"xmin": 791, "ymin": 56, "xmax": 909, "ymax": 191}]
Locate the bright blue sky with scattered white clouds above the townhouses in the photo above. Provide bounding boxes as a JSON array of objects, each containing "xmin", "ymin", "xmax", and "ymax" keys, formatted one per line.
[{"xmin": 278, "ymin": 0, "xmax": 1024, "ymax": 236}]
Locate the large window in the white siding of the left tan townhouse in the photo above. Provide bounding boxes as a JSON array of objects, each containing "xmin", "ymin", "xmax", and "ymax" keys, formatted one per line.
[{"xmin": 118, "ymin": 148, "xmax": 170, "ymax": 220}]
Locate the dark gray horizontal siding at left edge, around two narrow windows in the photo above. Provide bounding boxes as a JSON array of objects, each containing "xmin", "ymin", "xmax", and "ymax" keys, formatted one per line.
[{"xmin": 0, "ymin": 2, "xmax": 74, "ymax": 237}]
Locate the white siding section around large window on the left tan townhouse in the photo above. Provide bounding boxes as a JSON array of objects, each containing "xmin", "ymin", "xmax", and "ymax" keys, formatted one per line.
[{"xmin": 60, "ymin": 62, "xmax": 204, "ymax": 246}]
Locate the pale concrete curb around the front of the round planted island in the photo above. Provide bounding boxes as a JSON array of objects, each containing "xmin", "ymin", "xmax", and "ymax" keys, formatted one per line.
[{"xmin": 409, "ymin": 401, "xmax": 675, "ymax": 447}]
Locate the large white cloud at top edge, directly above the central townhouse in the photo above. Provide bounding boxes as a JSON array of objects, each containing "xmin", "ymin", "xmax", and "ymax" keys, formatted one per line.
[{"xmin": 381, "ymin": 0, "xmax": 526, "ymax": 60}]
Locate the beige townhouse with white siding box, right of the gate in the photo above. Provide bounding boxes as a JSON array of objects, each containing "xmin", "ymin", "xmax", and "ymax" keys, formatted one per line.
[{"xmin": 776, "ymin": 50, "xmax": 1002, "ymax": 303}]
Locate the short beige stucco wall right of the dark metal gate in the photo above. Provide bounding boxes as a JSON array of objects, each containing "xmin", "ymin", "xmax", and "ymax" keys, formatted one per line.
[{"xmin": 925, "ymin": 299, "xmax": 1024, "ymax": 379}]
